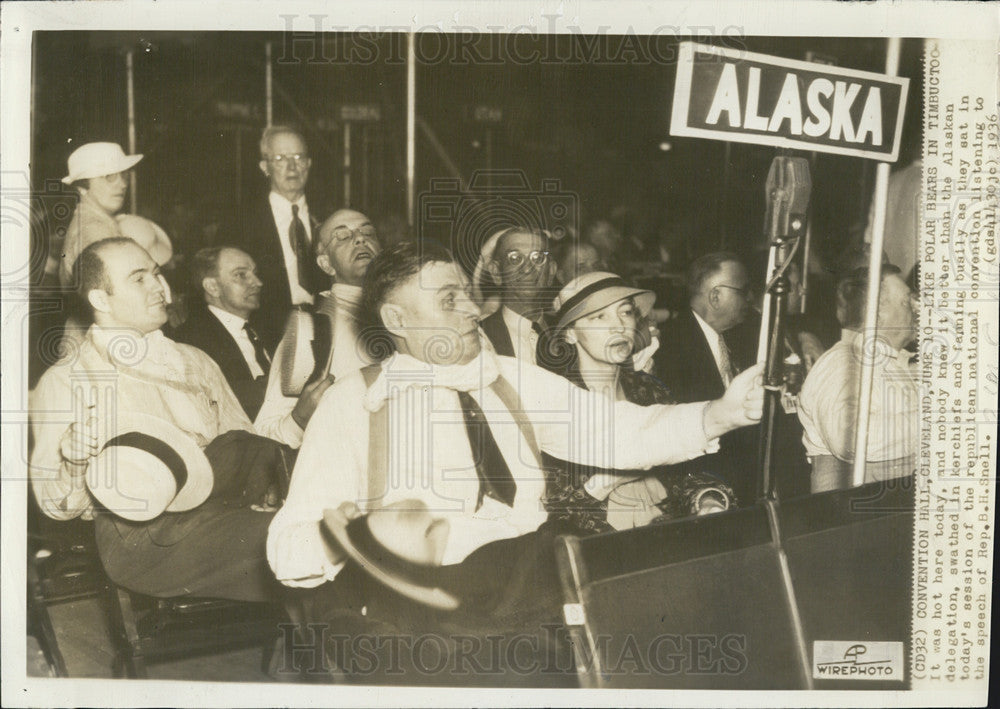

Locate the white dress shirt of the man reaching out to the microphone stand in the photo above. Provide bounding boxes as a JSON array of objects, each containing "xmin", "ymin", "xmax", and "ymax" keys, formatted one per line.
[{"xmin": 267, "ymin": 351, "xmax": 717, "ymax": 587}]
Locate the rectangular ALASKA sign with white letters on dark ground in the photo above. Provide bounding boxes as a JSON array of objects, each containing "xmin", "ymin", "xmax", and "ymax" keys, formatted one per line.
[{"xmin": 670, "ymin": 42, "xmax": 910, "ymax": 162}]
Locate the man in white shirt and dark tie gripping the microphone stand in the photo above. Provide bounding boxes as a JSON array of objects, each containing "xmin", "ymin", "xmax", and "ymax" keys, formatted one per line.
[{"xmin": 268, "ymin": 243, "xmax": 763, "ymax": 587}]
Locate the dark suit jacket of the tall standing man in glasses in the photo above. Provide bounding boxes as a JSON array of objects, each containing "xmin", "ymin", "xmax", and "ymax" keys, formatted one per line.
[{"xmin": 224, "ymin": 195, "xmax": 330, "ymax": 349}]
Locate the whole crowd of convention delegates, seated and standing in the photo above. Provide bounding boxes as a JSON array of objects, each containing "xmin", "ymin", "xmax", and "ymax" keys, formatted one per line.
[{"xmin": 23, "ymin": 126, "xmax": 917, "ymax": 684}]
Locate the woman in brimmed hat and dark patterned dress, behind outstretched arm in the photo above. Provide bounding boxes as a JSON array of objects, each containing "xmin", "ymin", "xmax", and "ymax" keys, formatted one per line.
[{"xmin": 538, "ymin": 271, "xmax": 733, "ymax": 533}]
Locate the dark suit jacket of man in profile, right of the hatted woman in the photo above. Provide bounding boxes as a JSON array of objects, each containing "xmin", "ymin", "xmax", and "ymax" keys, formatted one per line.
[{"xmin": 653, "ymin": 308, "xmax": 760, "ymax": 505}]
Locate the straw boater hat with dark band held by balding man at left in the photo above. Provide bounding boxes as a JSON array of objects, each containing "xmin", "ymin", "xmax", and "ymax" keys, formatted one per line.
[{"xmin": 87, "ymin": 413, "xmax": 213, "ymax": 522}]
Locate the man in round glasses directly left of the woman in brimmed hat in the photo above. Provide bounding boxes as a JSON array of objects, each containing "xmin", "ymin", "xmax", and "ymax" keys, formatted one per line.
[{"xmin": 480, "ymin": 226, "xmax": 556, "ymax": 364}]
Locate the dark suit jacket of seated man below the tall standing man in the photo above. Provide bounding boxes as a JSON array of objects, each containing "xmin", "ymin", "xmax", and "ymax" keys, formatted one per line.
[{"xmin": 173, "ymin": 305, "xmax": 274, "ymax": 421}]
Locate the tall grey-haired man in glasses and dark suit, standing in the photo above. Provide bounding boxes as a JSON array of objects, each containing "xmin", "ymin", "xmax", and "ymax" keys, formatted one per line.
[{"xmin": 228, "ymin": 125, "xmax": 329, "ymax": 347}]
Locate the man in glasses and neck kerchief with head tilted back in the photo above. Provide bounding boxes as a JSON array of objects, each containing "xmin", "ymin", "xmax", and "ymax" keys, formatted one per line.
[{"xmin": 254, "ymin": 209, "xmax": 381, "ymax": 448}]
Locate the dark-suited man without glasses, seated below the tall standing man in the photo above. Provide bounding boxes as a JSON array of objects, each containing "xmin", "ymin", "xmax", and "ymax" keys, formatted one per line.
[{"xmin": 174, "ymin": 246, "xmax": 274, "ymax": 418}]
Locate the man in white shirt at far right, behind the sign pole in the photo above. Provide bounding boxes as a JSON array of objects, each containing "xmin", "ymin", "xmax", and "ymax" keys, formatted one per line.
[{"xmin": 798, "ymin": 264, "xmax": 920, "ymax": 492}]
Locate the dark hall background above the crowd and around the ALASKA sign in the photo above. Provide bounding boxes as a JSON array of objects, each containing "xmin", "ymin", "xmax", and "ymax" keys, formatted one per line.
[{"xmin": 32, "ymin": 31, "xmax": 922, "ymax": 272}]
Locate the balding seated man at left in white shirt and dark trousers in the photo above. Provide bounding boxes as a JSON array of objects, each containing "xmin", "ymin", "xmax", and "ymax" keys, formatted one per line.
[{"xmin": 29, "ymin": 238, "xmax": 287, "ymax": 601}]
